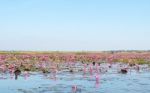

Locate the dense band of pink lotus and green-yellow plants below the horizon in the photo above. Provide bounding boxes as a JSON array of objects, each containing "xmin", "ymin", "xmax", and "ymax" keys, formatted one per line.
[{"xmin": 0, "ymin": 52, "xmax": 150, "ymax": 72}]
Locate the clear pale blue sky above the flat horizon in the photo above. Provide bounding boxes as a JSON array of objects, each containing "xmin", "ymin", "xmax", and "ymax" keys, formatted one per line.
[{"xmin": 0, "ymin": 0, "xmax": 150, "ymax": 51}]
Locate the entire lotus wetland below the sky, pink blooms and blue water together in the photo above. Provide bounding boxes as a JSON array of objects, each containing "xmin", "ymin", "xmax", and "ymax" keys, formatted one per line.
[{"xmin": 0, "ymin": 51, "xmax": 150, "ymax": 93}]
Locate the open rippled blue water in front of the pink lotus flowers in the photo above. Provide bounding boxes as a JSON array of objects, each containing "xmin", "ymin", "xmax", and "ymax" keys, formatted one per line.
[{"xmin": 0, "ymin": 63, "xmax": 150, "ymax": 93}]
